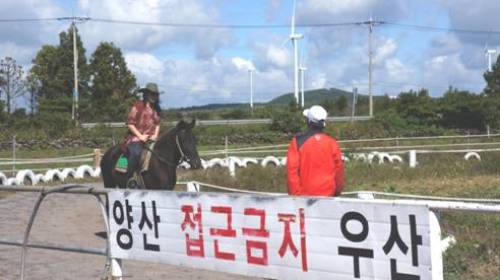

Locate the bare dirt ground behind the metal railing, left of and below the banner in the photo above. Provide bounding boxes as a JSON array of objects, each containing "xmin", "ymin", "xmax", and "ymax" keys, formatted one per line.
[{"xmin": 0, "ymin": 184, "xmax": 253, "ymax": 280}]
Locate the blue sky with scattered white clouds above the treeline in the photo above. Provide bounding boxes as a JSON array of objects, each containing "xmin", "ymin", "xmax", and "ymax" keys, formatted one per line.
[{"xmin": 0, "ymin": 0, "xmax": 500, "ymax": 108}]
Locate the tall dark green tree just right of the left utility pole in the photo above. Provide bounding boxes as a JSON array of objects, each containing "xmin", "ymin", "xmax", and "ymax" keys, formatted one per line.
[{"xmin": 87, "ymin": 42, "xmax": 137, "ymax": 121}]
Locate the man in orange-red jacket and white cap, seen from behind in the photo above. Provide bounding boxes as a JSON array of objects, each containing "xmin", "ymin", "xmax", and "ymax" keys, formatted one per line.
[{"xmin": 287, "ymin": 105, "xmax": 344, "ymax": 196}]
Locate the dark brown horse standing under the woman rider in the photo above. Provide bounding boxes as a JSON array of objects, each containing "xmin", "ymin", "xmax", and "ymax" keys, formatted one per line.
[{"xmin": 101, "ymin": 120, "xmax": 201, "ymax": 190}]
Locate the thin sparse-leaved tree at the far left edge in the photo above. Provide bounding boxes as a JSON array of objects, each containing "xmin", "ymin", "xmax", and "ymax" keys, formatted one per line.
[{"xmin": 0, "ymin": 57, "xmax": 24, "ymax": 114}]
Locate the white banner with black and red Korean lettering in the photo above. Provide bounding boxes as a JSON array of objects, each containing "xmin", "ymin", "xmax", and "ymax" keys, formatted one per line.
[{"xmin": 108, "ymin": 191, "xmax": 431, "ymax": 280}]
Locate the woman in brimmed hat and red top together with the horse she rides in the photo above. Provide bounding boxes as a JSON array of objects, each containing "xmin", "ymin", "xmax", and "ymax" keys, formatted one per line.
[{"xmin": 101, "ymin": 83, "xmax": 201, "ymax": 190}]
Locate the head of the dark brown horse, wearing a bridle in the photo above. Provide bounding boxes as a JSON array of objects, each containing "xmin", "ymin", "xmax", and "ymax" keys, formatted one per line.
[{"xmin": 176, "ymin": 119, "xmax": 201, "ymax": 169}]
